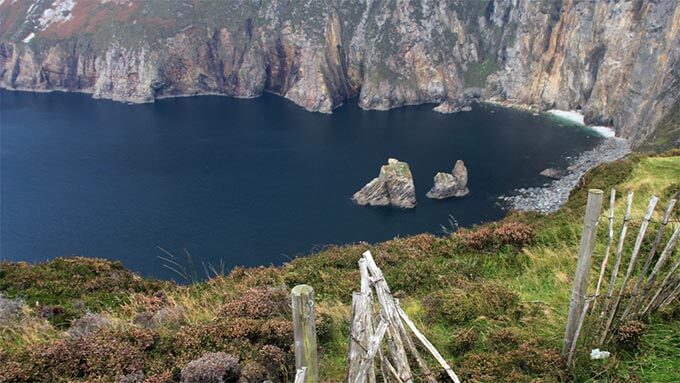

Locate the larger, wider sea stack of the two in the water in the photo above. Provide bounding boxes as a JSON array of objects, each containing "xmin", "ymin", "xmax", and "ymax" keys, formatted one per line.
[{"xmin": 352, "ymin": 158, "xmax": 416, "ymax": 209}]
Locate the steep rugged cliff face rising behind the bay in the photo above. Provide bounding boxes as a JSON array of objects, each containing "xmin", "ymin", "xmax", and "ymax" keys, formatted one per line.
[{"xmin": 0, "ymin": 0, "xmax": 680, "ymax": 142}]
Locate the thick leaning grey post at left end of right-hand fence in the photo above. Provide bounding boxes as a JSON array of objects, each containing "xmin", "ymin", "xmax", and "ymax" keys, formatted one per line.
[{"xmin": 562, "ymin": 189, "xmax": 603, "ymax": 355}]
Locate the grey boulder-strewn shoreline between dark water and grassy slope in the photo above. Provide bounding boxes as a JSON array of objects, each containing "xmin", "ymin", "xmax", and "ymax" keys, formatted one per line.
[{"xmin": 499, "ymin": 138, "xmax": 631, "ymax": 213}]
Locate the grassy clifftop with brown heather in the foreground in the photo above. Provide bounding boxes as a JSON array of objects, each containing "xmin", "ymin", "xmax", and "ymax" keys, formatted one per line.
[{"xmin": 0, "ymin": 151, "xmax": 680, "ymax": 382}]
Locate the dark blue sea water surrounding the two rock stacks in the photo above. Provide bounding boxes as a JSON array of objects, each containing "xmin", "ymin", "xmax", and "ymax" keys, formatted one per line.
[{"xmin": 0, "ymin": 91, "xmax": 600, "ymax": 278}]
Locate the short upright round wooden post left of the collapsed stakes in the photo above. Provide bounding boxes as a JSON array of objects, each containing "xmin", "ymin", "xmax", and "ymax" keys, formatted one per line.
[{"xmin": 291, "ymin": 285, "xmax": 319, "ymax": 383}]
